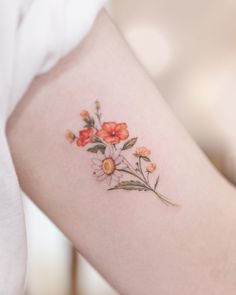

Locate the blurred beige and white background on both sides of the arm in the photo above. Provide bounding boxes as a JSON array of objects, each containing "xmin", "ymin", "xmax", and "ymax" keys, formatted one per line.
[{"xmin": 25, "ymin": 0, "xmax": 236, "ymax": 295}]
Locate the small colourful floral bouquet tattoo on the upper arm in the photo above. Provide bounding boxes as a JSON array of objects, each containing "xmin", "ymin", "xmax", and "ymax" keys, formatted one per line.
[{"xmin": 66, "ymin": 101, "xmax": 176, "ymax": 206}]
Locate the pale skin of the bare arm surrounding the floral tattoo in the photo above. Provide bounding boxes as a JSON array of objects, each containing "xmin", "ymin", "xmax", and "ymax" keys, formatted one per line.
[{"xmin": 7, "ymin": 11, "xmax": 236, "ymax": 295}]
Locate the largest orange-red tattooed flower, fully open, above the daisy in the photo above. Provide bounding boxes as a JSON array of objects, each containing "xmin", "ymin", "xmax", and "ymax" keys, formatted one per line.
[{"xmin": 96, "ymin": 122, "xmax": 129, "ymax": 144}]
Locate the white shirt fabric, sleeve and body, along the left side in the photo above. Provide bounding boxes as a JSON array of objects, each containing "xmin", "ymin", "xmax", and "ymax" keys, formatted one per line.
[{"xmin": 0, "ymin": 0, "xmax": 104, "ymax": 295}]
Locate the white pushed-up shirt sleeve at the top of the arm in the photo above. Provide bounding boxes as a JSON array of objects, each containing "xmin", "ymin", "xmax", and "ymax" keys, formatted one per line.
[{"xmin": 9, "ymin": 0, "xmax": 105, "ymax": 117}]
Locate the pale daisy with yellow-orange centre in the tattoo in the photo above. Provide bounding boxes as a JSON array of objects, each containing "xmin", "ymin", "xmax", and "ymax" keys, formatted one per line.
[{"xmin": 92, "ymin": 145, "xmax": 127, "ymax": 185}]
